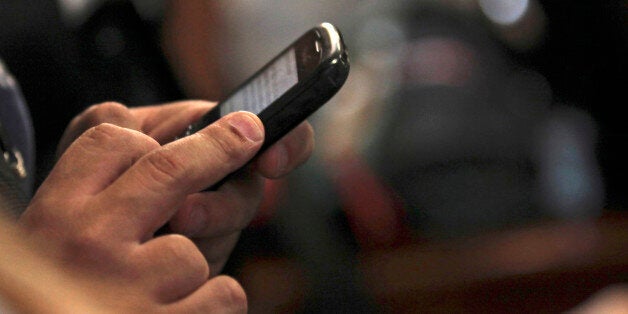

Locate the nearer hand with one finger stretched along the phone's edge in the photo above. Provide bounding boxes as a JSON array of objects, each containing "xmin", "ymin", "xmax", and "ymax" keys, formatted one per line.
[{"xmin": 20, "ymin": 108, "xmax": 280, "ymax": 312}]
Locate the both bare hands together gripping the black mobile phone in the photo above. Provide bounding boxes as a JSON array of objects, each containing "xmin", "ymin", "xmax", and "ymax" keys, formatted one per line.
[{"xmin": 14, "ymin": 101, "xmax": 313, "ymax": 312}]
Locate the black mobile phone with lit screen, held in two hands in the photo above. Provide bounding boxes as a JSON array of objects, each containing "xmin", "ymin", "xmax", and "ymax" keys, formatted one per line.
[{"xmin": 189, "ymin": 23, "xmax": 349, "ymax": 190}]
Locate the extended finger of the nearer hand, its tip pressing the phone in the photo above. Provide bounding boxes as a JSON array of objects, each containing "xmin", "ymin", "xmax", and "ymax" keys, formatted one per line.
[{"xmin": 102, "ymin": 112, "xmax": 264, "ymax": 238}]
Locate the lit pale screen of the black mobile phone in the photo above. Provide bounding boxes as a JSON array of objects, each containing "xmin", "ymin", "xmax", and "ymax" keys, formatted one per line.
[{"xmin": 220, "ymin": 49, "xmax": 299, "ymax": 116}]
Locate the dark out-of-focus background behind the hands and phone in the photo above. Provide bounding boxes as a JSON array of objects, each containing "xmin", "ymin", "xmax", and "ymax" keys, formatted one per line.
[{"xmin": 0, "ymin": 0, "xmax": 628, "ymax": 313}]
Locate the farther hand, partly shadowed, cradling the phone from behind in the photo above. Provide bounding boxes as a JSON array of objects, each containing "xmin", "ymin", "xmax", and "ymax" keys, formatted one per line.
[{"xmin": 54, "ymin": 101, "xmax": 314, "ymax": 275}]
